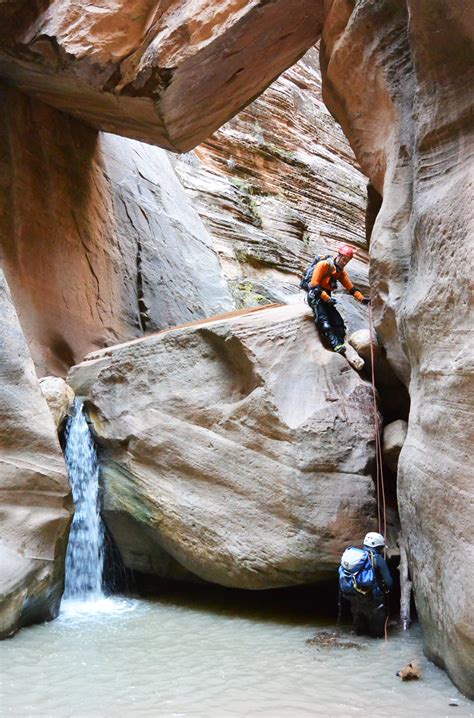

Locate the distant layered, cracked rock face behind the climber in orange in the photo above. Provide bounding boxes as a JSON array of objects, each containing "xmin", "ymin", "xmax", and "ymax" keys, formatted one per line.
[{"xmin": 175, "ymin": 48, "xmax": 367, "ymax": 320}]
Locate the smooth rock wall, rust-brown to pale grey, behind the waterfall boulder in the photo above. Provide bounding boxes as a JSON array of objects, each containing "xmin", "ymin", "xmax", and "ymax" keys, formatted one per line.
[{"xmin": 0, "ymin": 88, "xmax": 234, "ymax": 375}]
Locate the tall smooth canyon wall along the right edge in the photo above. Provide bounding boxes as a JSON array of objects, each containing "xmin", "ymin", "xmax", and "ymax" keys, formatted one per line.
[{"xmin": 322, "ymin": 0, "xmax": 474, "ymax": 695}]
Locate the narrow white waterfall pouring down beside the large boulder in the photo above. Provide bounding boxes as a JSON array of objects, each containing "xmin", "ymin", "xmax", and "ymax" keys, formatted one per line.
[{"xmin": 64, "ymin": 399, "xmax": 104, "ymax": 601}]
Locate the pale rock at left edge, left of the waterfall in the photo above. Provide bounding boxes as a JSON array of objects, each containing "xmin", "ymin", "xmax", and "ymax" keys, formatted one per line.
[{"xmin": 0, "ymin": 271, "xmax": 72, "ymax": 638}]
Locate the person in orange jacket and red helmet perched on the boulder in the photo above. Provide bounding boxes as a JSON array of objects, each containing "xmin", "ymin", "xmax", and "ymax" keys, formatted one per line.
[{"xmin": 300, "ymin": 244, "xmax": 370, "ymax": 354}]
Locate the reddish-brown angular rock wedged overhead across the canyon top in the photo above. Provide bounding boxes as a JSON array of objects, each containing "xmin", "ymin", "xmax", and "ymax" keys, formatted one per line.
[{"xmin": 0, "ymin": 0, "xmax": 323, "ymax": 151}]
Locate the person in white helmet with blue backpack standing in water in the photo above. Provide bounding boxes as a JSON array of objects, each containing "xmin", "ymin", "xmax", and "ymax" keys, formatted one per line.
[{"xmin": 339, "ymin": 531, "xmax": 393, "ymax": 638}]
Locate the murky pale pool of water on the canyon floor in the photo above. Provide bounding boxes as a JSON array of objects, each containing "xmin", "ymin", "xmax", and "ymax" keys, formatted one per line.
[{"xmin": 0, "ymin": 596, "xmax": 474, "ymax": 718}]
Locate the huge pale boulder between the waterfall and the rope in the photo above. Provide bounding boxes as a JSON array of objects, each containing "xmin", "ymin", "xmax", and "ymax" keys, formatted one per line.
[{"xmin": 68, "ymin": 305, "xmax": 375, "ymax": 589}]
